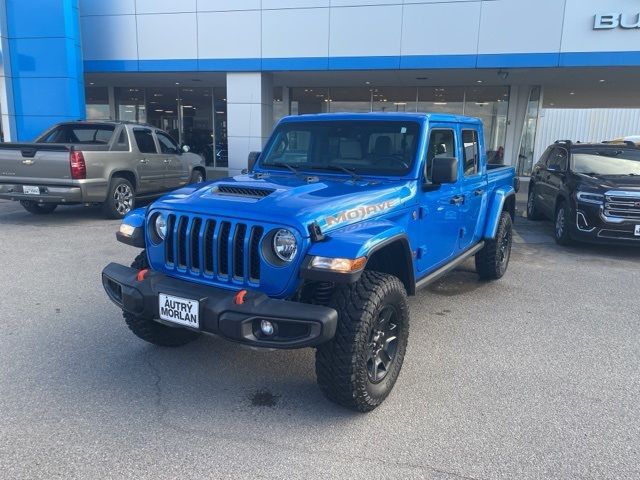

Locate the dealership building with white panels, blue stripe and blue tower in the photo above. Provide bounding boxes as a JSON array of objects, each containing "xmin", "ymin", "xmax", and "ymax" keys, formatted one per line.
[{"xmin": 0, "ymin": 0, "xmax": 640, "ymax": 176}]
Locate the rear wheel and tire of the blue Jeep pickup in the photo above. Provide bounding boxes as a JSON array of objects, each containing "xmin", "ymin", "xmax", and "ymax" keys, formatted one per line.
[{"xmin": 475, "ymin": 212, "xmax": 513, "ymax": 280}]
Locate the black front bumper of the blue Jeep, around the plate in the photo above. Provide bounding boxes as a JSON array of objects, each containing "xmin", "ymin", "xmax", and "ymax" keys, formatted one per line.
[{"xmin": 102, "ymin": 263, "xmax": 338, "ymax": 348}]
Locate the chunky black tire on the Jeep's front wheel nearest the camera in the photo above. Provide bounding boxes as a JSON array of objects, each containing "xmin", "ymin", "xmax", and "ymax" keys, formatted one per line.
[{"xmin": 316, "ymin": 271, "xmax": 409, "ymax": 412}]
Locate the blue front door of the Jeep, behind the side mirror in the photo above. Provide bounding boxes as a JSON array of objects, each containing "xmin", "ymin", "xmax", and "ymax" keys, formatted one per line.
[{"xmin": 417, "ymin": 123, "xmax": 460, "ymax": 275}]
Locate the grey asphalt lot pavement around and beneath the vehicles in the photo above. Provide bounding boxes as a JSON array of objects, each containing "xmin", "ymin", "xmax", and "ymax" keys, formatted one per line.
[{"xmin": 0, "ymin": 197, "xmax": 640, "ymax": 479}]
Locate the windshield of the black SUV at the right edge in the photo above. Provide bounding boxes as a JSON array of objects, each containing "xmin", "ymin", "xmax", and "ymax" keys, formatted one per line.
[{"xmin": 571, "ymin": 148, "xmax": 640, "ymax": 176}]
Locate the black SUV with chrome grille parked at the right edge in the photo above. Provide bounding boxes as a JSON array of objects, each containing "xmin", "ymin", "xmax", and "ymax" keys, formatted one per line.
[{"xmin": 527, "ymin": 140, "xmax": 640, "ymax": 245}]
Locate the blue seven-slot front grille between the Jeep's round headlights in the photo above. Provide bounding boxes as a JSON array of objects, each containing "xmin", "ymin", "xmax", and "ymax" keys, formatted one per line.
[{"xmin": 164, "ymin": 214, "xmax": 264, "ymax": 284}]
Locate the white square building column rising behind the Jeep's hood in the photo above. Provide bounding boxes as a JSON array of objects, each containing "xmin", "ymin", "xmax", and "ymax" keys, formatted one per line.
[{"xmin": 227, "ymin": 72, "xmax": 273, "ymax": 175}]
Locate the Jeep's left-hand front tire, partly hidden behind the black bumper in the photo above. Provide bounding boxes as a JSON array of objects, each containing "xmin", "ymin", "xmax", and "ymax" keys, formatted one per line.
[{"xmin": 122, "ymin": 250, "xmax": 200, "ymax": 347}]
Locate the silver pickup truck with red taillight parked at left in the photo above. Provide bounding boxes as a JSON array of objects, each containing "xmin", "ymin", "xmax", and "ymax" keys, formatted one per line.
[{"xmin": 0, "ymin": 121, "xmax": 206, "ymax": 218}]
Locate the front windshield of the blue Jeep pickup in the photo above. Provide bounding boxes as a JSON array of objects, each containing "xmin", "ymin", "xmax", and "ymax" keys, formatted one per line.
[{"xmin": 260, "ymin": 120, "xmax": 420, "ymax": 175}]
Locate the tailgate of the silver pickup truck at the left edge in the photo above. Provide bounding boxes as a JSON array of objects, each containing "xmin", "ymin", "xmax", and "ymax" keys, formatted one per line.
[{"xmin": 0, "ymin": 143, "xmax": 71, "ymax": 184}]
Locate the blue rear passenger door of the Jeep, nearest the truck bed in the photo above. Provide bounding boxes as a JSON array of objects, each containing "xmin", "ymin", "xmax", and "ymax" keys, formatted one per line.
[{"xmin": 459, "ymin": 125, "xmax": 487, "ymax": 250}]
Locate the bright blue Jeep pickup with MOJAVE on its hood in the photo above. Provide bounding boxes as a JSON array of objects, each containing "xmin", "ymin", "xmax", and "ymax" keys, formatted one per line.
[{"xmin": 102, "ymin": 114, "xmax": 515, "ymax": 411}]
